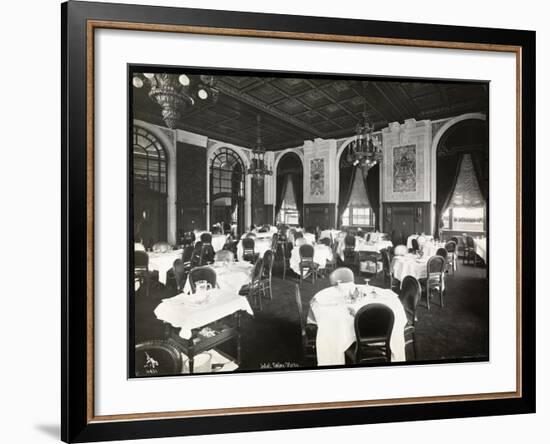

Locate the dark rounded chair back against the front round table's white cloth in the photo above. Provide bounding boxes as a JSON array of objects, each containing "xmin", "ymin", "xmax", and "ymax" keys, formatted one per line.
[{"xmin": 354, "ymin": 304, "xmax": 395, "ymax": 348}]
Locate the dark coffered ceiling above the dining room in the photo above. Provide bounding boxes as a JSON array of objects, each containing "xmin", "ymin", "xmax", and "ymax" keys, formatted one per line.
[{"xmin": 133, "ymin": 75, "xmax": 488, "ymax": 150}]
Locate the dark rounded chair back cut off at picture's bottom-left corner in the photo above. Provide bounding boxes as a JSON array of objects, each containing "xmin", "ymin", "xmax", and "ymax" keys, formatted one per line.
[{"xmin": 134, "ymin": 340, "xmax": 183, "ymax": 377}]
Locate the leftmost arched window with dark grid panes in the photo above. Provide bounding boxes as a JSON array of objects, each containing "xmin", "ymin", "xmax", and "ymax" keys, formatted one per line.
[{"xmin": 133, "ymin": 127, "xmax": 166, "ymax": 194}]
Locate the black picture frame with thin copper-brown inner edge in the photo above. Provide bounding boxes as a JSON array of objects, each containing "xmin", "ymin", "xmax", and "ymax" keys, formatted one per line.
[{"xmin": 61, "ymin": 1, "xmax": 536, "ymax": 442}]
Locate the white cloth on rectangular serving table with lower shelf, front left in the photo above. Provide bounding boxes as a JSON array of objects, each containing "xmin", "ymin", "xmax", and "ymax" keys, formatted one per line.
[{"xmin": 155, "ymin": 288, "xmax": 254, "ymax": 339}]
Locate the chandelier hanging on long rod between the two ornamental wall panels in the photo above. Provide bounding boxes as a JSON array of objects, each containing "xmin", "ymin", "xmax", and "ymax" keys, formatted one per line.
[{"xmin": 347, "ymin": 83, "xmax": 383, "ymax": 171}]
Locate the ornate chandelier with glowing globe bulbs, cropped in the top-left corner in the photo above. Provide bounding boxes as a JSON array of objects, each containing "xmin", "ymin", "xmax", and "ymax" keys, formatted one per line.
[{"xmin": 132, "ymin": 73, "xmax": 218, "ymax": 128}]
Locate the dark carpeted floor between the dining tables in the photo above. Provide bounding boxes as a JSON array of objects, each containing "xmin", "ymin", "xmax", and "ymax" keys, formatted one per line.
[{"xmin": 135, "ymin": 256, "xmax": 489, "ymax": 370}]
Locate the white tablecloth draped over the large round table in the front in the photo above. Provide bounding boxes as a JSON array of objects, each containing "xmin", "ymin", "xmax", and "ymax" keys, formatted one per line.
[{"xmin": 308, "ymin": 285, "xmax": 407, "ymax": 365}]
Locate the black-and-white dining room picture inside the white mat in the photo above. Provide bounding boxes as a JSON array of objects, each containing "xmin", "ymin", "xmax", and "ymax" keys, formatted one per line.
[{"xmin": 130, "ymin": 70, "xmax": 492, "ymax": 378}]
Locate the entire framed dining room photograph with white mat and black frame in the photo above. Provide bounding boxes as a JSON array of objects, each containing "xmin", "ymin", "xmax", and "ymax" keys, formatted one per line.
[{"xmin": 61, "ymin": 1, "xmax": 535, "ymax": 442}]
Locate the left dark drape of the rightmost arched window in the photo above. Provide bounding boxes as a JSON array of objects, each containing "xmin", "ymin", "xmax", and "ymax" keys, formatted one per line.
[{"xmin": 434, "ymin": 153, "xmax": 464, "ymax": 236}]
